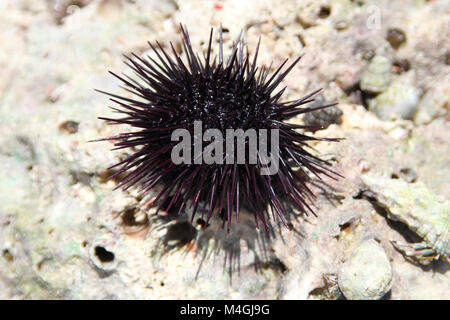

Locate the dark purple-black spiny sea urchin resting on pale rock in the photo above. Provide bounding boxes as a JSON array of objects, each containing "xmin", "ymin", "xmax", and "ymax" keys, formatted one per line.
[{"xmin": 96, "ymin": 27, "xmax": 338, "ymax": 230}]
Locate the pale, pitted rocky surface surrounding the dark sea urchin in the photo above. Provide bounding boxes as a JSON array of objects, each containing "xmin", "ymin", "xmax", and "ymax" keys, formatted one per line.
[{"xmin": 0, "ymin": 0, "xmax": 450, "ymax": 299}]
